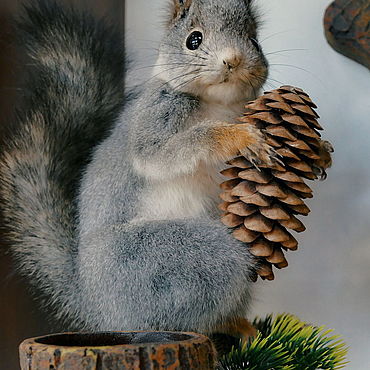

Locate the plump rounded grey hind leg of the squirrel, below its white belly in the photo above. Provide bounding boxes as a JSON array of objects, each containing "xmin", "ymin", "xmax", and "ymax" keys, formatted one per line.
[{"xmin": 79, "ymin": 220, "xmax": 254, "ymax": 333}]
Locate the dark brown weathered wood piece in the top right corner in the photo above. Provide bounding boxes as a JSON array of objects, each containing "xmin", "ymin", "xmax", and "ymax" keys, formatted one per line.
[{"xmin": 324, "ymin": 0, "xmax": 370, "ymax": 69}]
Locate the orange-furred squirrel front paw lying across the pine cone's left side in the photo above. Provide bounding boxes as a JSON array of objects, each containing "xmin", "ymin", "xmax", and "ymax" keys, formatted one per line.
[{"xmin": 213, "ymin": 124, "xmax": 279, "ymax": 167}]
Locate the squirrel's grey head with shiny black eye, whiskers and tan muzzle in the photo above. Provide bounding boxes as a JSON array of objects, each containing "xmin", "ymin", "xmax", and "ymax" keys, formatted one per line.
[{"xmin": 154, "ymin": 0, "xmax": 268, "ymax": 104}]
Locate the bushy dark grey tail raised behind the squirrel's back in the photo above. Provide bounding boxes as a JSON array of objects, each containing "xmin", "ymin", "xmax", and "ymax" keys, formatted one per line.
[{"xmin": 0, "ymin": 0, "xmax": 124, "ymax": 324}]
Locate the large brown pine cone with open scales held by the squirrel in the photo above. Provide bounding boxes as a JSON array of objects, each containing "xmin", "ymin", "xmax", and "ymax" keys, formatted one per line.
[{"xmin": 220, "ymin": 86, "xmax": 333, "ymax": 280}]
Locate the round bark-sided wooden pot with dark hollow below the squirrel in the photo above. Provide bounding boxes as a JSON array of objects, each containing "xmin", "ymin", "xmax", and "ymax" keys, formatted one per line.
[{"xmin": 19, "ymin": 332, "xmax": 216, "ymax": 370}]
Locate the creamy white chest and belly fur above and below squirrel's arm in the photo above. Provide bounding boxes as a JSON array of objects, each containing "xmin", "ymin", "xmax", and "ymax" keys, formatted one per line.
[{"xmin": 138, "ymin": 103, "xmax": 246, "ymax": 220}]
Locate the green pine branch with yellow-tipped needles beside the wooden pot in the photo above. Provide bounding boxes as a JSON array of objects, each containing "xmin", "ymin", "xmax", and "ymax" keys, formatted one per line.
[{"xmin": 220, "ymin": 315, "xmax": 347, "ymax": 370}]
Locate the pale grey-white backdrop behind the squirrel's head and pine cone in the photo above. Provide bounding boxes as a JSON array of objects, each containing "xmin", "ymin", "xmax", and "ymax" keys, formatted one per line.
[{"xmin": 126, "ymin": 0, "xmax": 370, "ymax": 370}]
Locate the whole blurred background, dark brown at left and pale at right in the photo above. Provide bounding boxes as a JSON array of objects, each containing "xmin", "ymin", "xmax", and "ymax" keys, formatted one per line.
[{"xmin": 0, "ymin": 0, "xmax": 370, "ymax": 370}]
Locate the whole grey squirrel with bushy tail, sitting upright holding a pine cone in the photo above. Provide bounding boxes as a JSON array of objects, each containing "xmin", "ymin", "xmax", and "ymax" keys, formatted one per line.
[{"xmin": 0, "ymin": 0, "xmax": 332, "ymax": 338}]
